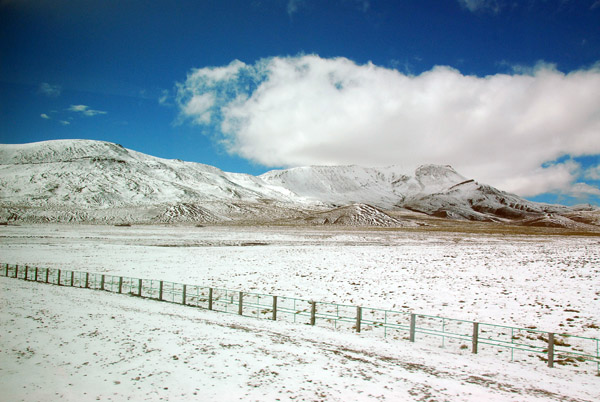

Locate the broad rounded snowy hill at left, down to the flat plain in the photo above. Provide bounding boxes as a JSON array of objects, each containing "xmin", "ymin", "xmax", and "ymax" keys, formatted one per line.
[{"xmin": 0, "ymin": 140, "xmax": 310, "ymax": 222}]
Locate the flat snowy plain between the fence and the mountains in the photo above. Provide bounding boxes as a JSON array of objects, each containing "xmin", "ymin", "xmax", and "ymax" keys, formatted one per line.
[{"xmin": 0, "ymin": 225, "xmax": 600, "ymax": 338}]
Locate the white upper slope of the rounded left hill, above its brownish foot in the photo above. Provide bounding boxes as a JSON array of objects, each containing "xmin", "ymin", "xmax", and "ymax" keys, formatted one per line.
[{"xmin": 0, "ymin": 140, "xmax": 300, "ymax": 207}]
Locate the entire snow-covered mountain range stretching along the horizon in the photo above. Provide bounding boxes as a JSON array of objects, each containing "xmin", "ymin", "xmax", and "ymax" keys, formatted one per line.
[{"xmin": 0, "ymin": 140, "xmax": 596, "ymax": 226}]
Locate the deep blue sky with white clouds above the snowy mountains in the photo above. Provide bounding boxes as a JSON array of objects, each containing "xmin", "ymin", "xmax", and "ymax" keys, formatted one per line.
[{"xmin": 0, "ymin": 0, "xmax": 600, "ymax": 205}]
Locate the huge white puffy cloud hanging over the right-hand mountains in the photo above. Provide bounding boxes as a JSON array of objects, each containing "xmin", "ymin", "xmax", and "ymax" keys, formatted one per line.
[{"xmin": 177, "ymin": 55, "xmax": 600, "ymax": 196}]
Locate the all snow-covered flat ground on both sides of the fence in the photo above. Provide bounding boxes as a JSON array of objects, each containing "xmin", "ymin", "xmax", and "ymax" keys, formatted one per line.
[{"xmin": 0, "ymin": 225, "xmax": 600, "ymax": 401}]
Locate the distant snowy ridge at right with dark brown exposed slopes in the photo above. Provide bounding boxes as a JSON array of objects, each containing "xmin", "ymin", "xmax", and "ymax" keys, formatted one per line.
[{"xmin": 260, "ymin": 165, "xmax": 594, "ymax": 228}]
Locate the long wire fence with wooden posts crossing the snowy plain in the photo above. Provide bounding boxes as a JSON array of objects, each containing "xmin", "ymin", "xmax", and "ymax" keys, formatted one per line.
[{"xmin": 0, "ymin": 264, "xmax": 600, "ymax": 375}]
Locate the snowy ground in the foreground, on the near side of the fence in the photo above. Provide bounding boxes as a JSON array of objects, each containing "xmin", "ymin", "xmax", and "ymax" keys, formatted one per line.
[{"xmin": 0, "ymin": 278, "xmax": 600, "ymax": 401}]
